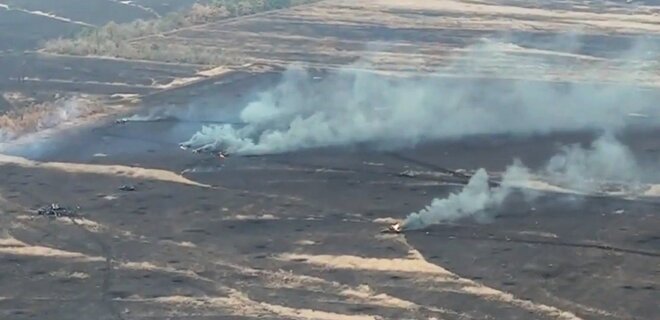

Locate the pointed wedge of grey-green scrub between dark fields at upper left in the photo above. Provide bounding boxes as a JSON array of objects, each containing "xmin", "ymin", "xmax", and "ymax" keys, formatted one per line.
[{"xmin": 44, "ymin": 0, "xmax": 318, "ymax": 65}]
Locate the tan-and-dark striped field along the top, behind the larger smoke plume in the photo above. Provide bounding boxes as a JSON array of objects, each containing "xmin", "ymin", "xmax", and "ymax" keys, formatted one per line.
[{"xmin": 137, "ymin": 0, "xmax": 660, "ymax": 82}]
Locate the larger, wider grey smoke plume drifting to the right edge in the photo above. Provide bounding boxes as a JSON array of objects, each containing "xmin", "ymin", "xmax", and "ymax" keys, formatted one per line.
[{"xmin": 183, "ymin": 37, "xmax": 657, "ymax": 154}]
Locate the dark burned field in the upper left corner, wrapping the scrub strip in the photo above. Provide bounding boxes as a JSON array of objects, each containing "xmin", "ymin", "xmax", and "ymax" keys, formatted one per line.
[{"xmin": 0, "ymin": 0, "xmax": 219, "ymax": 109}]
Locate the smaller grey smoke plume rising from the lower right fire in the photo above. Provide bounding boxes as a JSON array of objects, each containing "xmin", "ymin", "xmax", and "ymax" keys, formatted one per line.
[{"xmin": 402, "ymin": 134, "xmax": 641, "ymax": 230}]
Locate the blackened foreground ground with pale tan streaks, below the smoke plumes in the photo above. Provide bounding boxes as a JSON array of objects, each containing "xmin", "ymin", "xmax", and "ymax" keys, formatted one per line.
[{"xmin": 0, "ymin": 70, "xmax": 660, "ymax": 319}]
